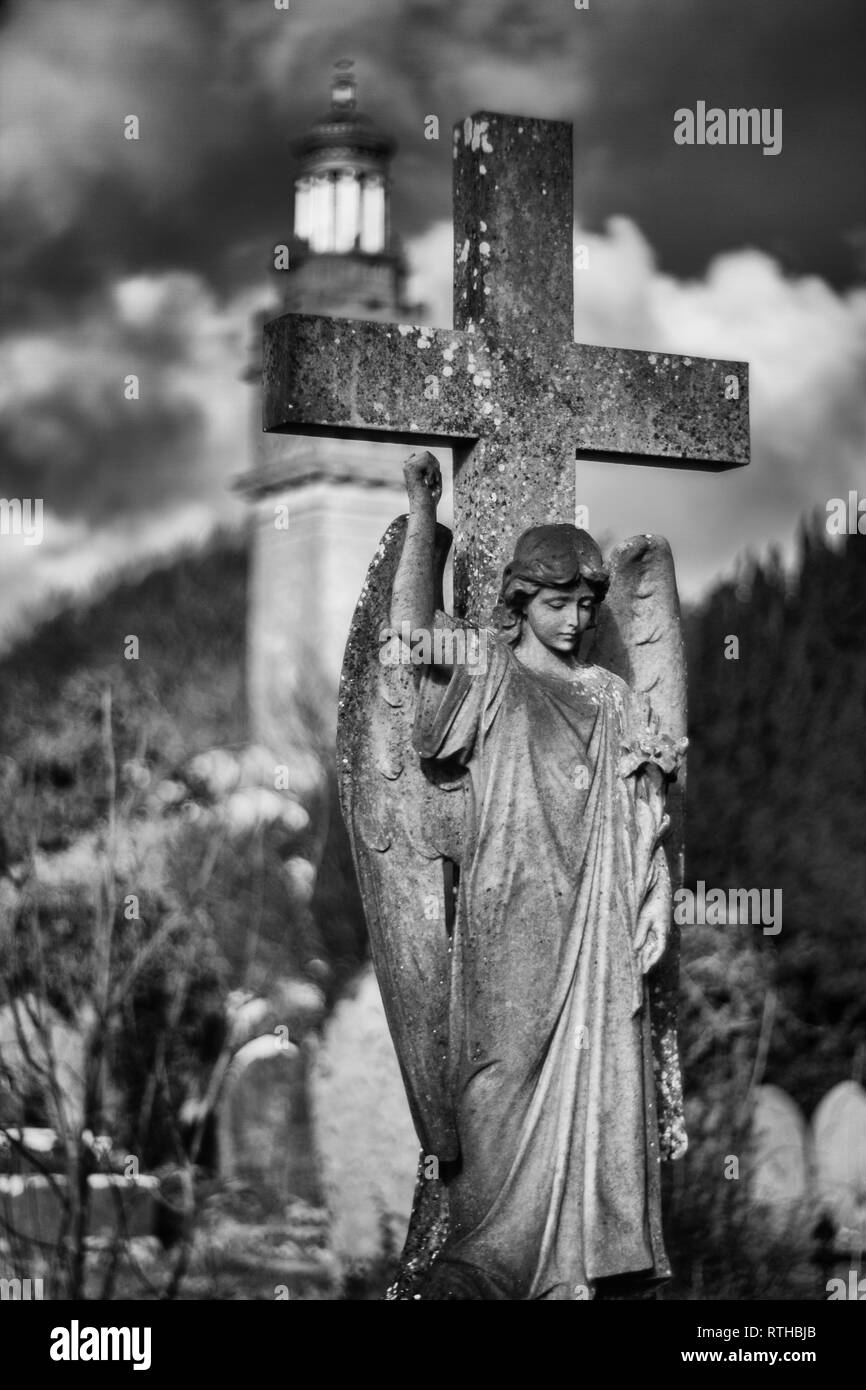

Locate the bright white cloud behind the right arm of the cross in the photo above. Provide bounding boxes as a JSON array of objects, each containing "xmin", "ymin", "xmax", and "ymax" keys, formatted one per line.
[{"xmin": 409, "ymin": 217, "xmax": 866, "ymax": 598}]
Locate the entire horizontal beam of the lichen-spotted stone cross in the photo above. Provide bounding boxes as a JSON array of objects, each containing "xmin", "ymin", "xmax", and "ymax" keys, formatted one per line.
[{"xmin": 263, "ymin": 314, "xmax": 749, "ymax": 470}]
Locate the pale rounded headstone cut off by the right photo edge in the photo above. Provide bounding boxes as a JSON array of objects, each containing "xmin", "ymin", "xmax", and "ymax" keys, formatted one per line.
[{"xmin": 812, "ymin": 1081, "xmax": 866, "ymax": 1259}]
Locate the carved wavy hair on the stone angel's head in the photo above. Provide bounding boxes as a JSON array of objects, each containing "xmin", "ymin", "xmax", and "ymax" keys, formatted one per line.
[{"xmin": 493, "ymin": 523, "xmax": 610, "ymax": 644}]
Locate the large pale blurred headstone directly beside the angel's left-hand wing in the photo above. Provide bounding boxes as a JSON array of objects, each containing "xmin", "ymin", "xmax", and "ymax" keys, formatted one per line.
[{"xmin": 310, "ymin": 966, "xmax": 418, "ymax": 1275}]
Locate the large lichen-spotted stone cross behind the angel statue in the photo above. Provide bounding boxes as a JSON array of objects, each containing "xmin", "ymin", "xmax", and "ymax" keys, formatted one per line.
[{"xmin": 263, "ymin": 113, "xmax": 749, "ymax": 621}]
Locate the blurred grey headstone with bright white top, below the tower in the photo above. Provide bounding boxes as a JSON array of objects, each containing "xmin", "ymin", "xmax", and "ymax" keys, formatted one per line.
[{"xmin": 217, "ymin": 1029, "xmax": 318, "ymax": 1202}]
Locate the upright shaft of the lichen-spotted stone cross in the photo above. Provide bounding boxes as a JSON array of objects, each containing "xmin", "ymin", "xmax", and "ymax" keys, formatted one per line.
[{"xmin": 453, "ymin": 111, "xmax": 574, "ymax": 620}]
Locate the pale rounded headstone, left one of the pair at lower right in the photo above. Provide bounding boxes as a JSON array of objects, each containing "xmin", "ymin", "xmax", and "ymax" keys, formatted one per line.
[{"xmin": 749, "ymin": 1086, "xmax": 809, "ymax": 1225}]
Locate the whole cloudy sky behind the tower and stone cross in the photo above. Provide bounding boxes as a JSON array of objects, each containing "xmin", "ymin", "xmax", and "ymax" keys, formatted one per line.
[{"xmin": 0, "ymin": 0, "xmax": 866, "ymax": 631}]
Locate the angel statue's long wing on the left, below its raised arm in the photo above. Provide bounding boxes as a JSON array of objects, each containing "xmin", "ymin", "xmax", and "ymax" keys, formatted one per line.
[{"xmin": 336, "ymin": 516, "xmax": 464, "ymax": 1161}]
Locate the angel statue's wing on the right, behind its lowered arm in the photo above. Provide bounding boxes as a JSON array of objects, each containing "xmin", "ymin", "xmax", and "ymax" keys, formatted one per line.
[{"xmin": 594, "ymin": 535, "xmax": 687, "ymax": 1158}]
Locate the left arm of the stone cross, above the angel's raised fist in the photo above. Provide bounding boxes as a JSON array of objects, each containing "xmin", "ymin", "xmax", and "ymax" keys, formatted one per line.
[{"xmin": 263, "ymin": 314, "xmax": 485, "ymax": 446}]
